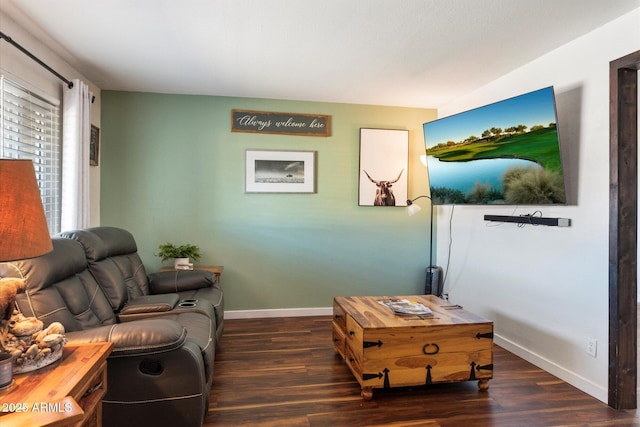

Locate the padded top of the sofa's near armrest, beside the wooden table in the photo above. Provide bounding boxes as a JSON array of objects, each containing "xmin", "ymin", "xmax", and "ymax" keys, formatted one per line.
[{"xmin": 65, "ymin": 319, "xmax": 187, "ymax": 357}]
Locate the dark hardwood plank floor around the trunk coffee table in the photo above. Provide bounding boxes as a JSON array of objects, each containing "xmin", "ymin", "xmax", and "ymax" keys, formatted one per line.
[{"xmin": 204, "ymin": 316, "xmax": 640, "ymax": 427}]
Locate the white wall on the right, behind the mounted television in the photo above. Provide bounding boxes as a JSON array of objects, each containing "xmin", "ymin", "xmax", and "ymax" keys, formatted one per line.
[{"xmin": 437, "ymin": 9, "xmax": 640, "ymax": 402}]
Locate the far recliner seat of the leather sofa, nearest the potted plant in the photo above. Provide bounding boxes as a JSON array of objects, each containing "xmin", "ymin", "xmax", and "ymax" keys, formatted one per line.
[{"xmin": 59, "ymin": 226, "xmax": 224, "ymax": 343}]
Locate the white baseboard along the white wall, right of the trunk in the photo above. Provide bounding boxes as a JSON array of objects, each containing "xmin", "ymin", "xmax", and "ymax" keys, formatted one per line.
[{"xmin": 493, "ymin": 335, "xmax": 609, "ymax": 403}]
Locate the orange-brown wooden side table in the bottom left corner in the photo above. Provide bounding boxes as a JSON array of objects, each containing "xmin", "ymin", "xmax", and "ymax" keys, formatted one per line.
[{"xmin": 0, "ymin": 342, "xmax": 113, "ymax": 427}]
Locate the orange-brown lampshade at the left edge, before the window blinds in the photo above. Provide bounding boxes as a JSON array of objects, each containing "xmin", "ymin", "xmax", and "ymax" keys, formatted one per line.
[{"xmin": 0, "ymin": 159, "xmax": 53, "ymax": 261}]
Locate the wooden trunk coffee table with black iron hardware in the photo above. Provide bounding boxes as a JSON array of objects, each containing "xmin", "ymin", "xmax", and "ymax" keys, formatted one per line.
[{"xmin": 333, "ymin": 295, "xmax": 493, "ymax": 400}]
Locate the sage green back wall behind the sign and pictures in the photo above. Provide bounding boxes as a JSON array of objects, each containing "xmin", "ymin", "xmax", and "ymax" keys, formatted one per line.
[{"xmin": 100, "ymin": 91, "xmax": 436, "ymax": 310}]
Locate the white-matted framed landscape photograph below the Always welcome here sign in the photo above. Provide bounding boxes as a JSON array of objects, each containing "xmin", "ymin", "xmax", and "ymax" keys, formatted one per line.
[{"xmin": 245, "ymin": 150, "xmax": 316, "ymax": 193}]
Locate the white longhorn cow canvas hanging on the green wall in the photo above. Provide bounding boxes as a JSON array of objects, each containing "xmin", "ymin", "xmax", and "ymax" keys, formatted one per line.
[{"xmin": 358, "ymin": 128, "xmax": 409, "ymax": 206}]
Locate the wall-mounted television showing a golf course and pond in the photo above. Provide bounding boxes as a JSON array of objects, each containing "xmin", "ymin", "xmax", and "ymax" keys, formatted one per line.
[{"xmin": 423, "ymin": 86, "xmax": 566, "ymax": 205}]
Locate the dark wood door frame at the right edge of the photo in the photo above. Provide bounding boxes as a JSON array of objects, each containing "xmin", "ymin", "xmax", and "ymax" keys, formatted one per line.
[{"xmin": 609, "ymin": 51, "xmax": 640, "ymax": 409}]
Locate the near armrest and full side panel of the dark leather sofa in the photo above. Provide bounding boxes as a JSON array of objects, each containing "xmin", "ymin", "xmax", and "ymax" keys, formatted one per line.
[{"xmin": 69, "ymin": 318, "xmax": 211, "ymax": 427}]
